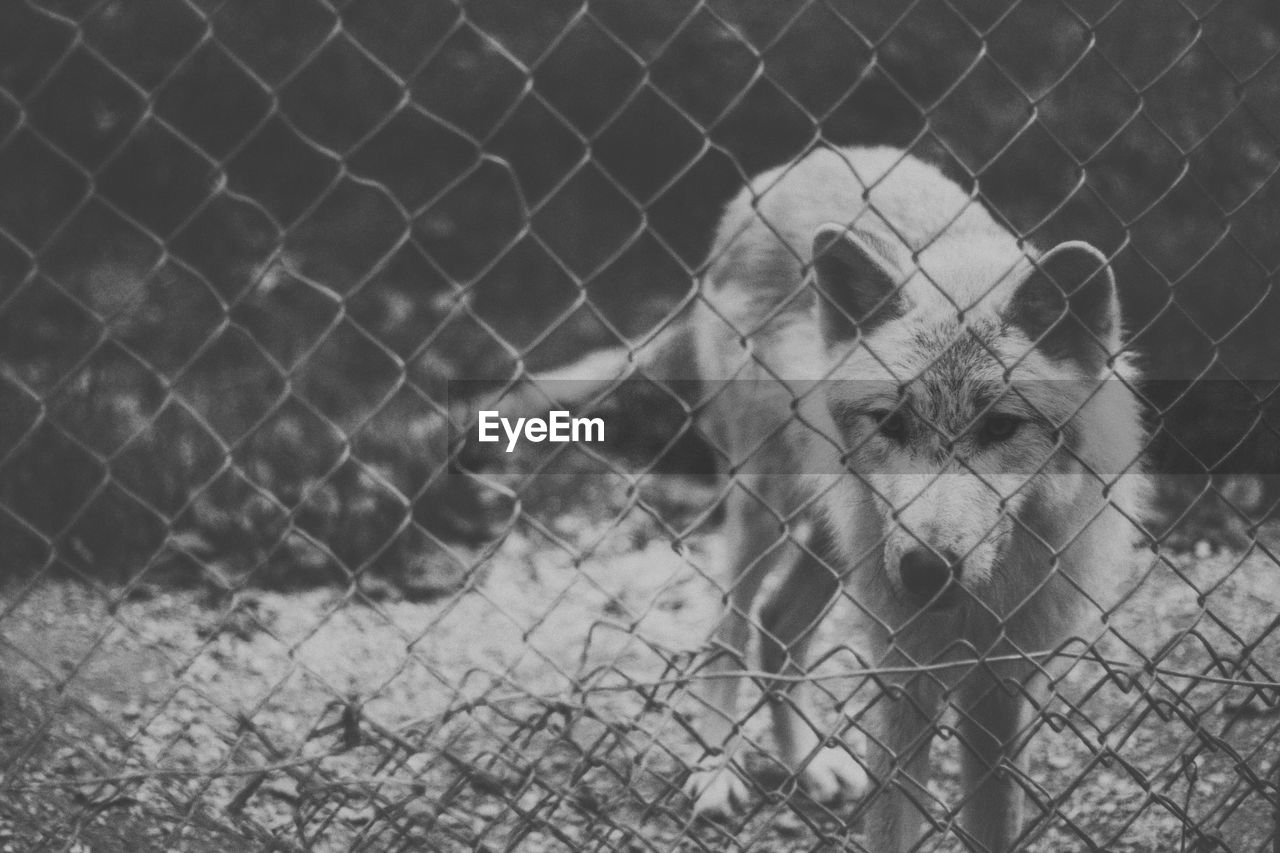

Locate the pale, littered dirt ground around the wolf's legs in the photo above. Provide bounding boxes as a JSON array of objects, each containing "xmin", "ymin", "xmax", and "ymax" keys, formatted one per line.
[{"xmin": 0, "ymin": 507, "xmax": 1280, "ymax": 853}]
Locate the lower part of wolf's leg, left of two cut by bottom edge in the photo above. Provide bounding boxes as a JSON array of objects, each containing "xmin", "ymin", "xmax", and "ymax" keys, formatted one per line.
[{"xmin": 867, "ymin": 676, "xmax": 942, "ymax": 853}]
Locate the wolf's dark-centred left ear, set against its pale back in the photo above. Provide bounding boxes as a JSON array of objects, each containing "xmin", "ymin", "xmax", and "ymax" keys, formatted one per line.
[{"xmin": 813, "ymin": 224, "xmax": 902, "ymax": 343}]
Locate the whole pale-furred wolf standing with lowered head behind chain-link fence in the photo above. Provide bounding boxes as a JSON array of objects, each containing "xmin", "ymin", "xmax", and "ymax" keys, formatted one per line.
[{"xmin": 685, "ymin": 147, "xmax": 1146, "ymax": 853}]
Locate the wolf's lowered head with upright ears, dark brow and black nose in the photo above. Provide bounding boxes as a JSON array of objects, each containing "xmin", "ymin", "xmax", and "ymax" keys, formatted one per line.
[{"xmin": 814, "ymin": 219, "xmax": 1137, "ymax": 608}]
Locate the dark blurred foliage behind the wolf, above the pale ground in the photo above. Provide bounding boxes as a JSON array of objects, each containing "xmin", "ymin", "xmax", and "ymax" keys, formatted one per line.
[{"xmin": 0, "ymin": 0, "xmax": 1280, "ymax": 594}]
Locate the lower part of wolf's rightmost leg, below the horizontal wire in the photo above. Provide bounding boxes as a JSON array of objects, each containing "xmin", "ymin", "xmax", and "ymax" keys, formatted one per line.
[{"xmin": 957, "ymin": 680, "xmax": 1032, "ymax": 853}]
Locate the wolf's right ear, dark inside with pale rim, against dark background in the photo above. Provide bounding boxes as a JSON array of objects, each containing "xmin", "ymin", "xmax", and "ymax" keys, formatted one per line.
[{"xmin": 1005, "ymin": 241, "xmax": 1120, "ymax": 369}]
